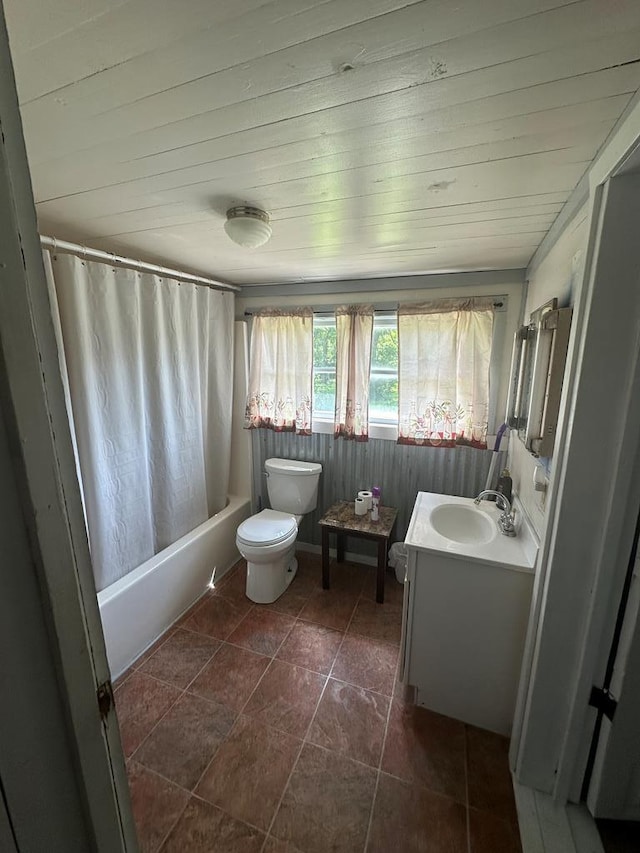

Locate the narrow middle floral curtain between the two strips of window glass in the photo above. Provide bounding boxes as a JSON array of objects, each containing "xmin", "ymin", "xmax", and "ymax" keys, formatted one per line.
[{"xmin": 333, "ymin": 305, "xmax": 373, "ymax": 441}]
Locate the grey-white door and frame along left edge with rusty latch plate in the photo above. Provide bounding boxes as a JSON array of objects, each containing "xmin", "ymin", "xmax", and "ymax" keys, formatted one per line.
[{"xmin": 0, "ymin": 7, "xmax": 137, "ymax": 853}]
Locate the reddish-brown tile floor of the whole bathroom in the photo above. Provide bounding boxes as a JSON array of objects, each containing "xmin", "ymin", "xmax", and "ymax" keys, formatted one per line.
[{"xmin": 116, "ymin": 554, "xmax": 521, "ymax": 853}]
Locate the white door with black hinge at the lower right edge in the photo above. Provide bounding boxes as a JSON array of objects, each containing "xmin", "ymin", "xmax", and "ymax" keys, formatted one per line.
[{"xmin": 587, "ymin": 528, "xmax": 640, "ymax": 820}]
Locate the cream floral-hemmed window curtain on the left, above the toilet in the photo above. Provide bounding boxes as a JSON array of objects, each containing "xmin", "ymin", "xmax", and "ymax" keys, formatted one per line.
[{"xmin": 244, "ymin": 308, "xmax": 313, "ymax": 435}]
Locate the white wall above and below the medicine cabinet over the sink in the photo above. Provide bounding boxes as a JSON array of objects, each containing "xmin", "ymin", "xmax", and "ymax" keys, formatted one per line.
[{"xmin": 509, "ymin": 205, "xmax": 589, "ymax": 536}]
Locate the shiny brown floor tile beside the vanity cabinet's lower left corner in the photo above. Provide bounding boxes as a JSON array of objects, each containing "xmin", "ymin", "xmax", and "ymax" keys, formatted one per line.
[{"xmin": 331, "ymin": 634, "xmax": 398, "ymax": 696}]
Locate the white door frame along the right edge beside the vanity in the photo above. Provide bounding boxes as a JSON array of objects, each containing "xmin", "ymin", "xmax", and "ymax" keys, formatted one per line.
[{"xmin": 511, "ymin": 90, "xmax": 640, "ymax": 802}]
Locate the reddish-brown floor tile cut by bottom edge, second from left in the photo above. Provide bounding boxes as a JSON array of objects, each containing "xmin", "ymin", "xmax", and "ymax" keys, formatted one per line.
[{"xmin": 162, "ymin": 797, "xmax": 264, "ymax": 853}]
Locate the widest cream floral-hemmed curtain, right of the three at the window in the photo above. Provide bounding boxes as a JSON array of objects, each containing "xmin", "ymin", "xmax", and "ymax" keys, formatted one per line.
[{"xmin": 398, "ymin": 298, "xmax": 493, "ymax": 448}]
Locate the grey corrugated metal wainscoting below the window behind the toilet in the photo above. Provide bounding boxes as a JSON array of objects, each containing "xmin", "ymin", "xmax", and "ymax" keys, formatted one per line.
[{"xmin": 253, "ymin": 429, "xmax": 506, "ymax": 554}]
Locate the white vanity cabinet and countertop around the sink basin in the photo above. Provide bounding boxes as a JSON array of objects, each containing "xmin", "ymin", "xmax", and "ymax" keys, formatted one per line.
[{"xmin": 401, "ymin": 492, "xmax": 537, "ymax": 735}]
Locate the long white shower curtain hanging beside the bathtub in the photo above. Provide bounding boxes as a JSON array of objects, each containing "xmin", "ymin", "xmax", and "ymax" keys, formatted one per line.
[{"xmin": 45, "ymin": 252, "xmax": 234, "ymax": 590}]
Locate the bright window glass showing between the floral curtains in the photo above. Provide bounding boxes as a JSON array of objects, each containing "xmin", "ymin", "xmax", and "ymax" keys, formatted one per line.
[{"xmin": 313, "ymin": 311, "xmax": 398, "ymax": 437}]
